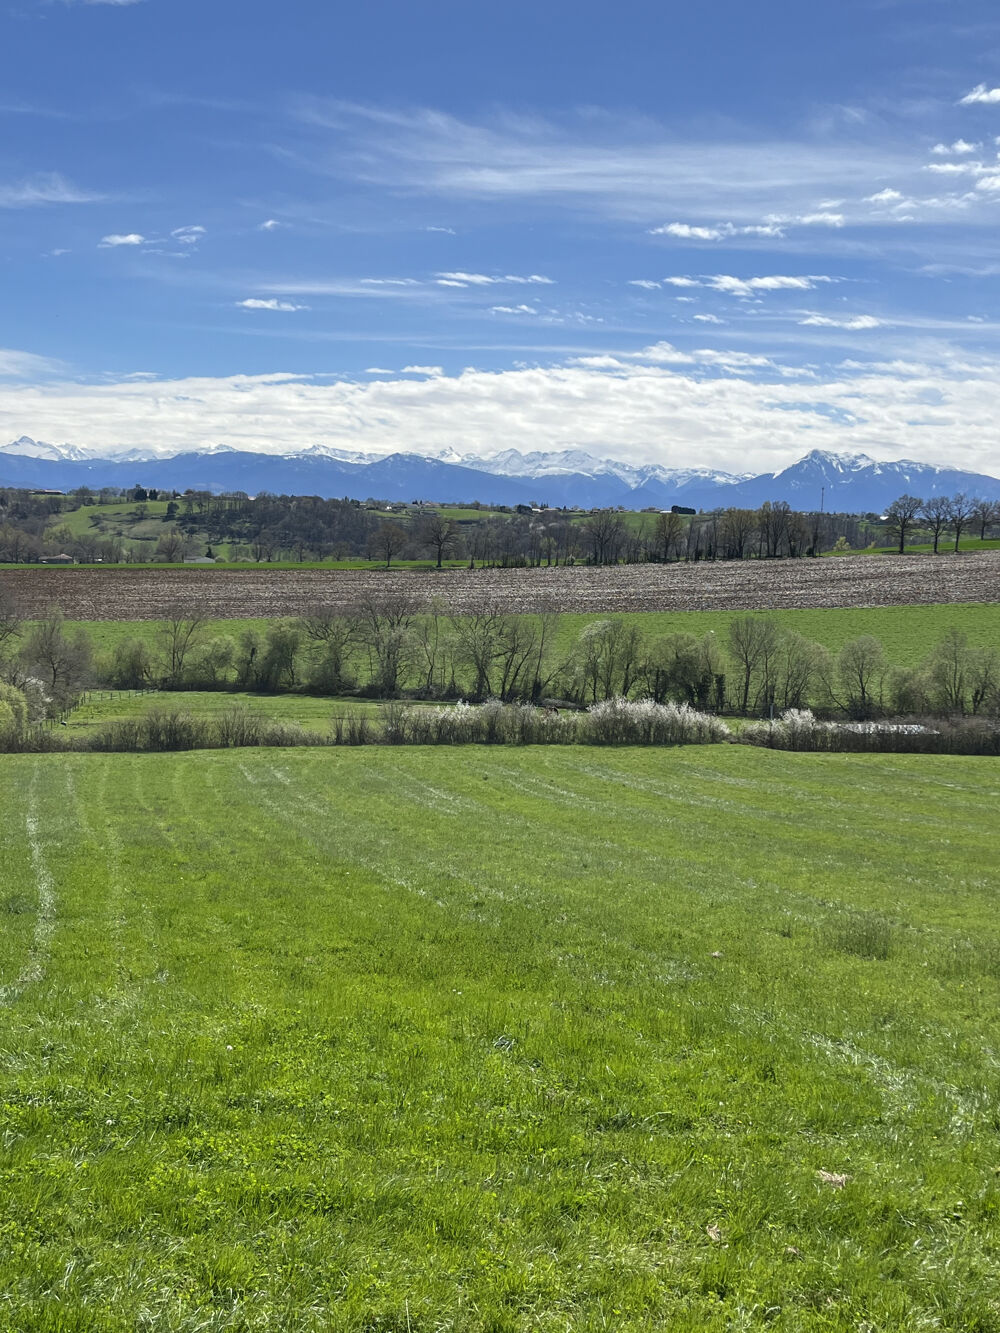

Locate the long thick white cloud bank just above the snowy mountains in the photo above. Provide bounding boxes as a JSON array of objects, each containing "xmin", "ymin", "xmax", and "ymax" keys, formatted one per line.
[{"xmin": 0, "ymin": 357, "xmax": 1000, "ymax": 472}]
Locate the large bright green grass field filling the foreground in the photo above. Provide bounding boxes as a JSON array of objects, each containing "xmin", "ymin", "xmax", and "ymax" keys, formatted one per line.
[{"xmin": 0, "ymin": 746, "xmax": 1000, "ymax": 1333}]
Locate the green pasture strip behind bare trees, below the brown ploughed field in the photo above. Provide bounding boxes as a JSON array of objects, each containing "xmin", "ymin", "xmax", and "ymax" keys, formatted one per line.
[{"xmin": 68, "ymin": 602, "xmax": 1000, "ymax": 667}]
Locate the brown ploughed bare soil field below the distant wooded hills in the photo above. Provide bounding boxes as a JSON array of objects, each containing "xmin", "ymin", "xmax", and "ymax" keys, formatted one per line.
[{"xmin": 0, "ymin": 551, "xmax": 1000, "ymax": 620}]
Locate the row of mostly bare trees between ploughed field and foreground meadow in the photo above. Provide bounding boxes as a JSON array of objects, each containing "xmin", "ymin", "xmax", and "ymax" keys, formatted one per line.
[{"xmin": 0, "ymin": 596, "xmax": 1000, "ymax": 720}]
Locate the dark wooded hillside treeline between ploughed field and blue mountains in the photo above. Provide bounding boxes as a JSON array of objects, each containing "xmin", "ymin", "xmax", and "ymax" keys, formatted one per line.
[{"xmin": 0, "ymin": 487, "xmax": 1000, "ymax": 568}]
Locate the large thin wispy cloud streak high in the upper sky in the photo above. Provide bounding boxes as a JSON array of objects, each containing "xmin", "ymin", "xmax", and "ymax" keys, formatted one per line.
[{"xmin": 288, "ymin": 97, "xmax": 913, "ymax": 227}]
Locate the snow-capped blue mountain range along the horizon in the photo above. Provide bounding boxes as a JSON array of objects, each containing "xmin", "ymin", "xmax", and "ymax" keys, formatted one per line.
[{"xmin": 0, "ymin": 436, "xmax": 1000, "ymax": 513}]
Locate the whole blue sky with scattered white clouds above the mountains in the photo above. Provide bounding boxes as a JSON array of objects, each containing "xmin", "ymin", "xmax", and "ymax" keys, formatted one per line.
[{"xmin": 0, "ymin": 0, "xmax": 1000, "ymax": 472}]
